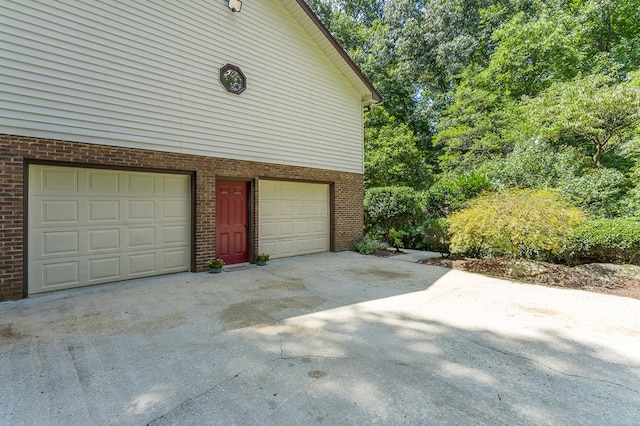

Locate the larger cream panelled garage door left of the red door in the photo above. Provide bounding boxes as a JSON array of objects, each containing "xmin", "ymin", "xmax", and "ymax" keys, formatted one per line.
[{"xmin": 27, "ymin": 165, "xmax": 191, "ymax": 294}]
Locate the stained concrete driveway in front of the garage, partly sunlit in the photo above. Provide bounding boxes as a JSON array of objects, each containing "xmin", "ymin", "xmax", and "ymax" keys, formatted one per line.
[{"xmin": 0, "ymin": 252, "xmax": 640, "ymax": 425}]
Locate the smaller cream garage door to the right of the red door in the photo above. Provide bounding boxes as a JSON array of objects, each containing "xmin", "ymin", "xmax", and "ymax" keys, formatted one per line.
[{"xmin": 258, "ymin": 180, "xmax": 330, "ymax": 259}]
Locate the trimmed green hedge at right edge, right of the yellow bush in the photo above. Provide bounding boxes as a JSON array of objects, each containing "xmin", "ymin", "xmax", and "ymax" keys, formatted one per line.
[{"xmin": 564, "ymin": 217, "xmax": 640, "ymax": 264}]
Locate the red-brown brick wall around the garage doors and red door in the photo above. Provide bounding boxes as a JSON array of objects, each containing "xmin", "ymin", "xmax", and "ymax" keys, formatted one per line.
[{"xmin": 0, "ymin": 135, "xmax": 364, "ymax": 300}]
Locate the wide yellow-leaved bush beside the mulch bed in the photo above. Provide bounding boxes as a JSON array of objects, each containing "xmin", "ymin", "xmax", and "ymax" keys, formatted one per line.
[{"xmin": 449, "ymin": 189, "xmax": 584, "ymax": 259}]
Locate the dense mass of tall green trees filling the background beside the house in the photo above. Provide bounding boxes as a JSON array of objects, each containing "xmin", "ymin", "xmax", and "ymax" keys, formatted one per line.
[{"xmin": 307, "ymin": 0, "xmax": 640, "ymax": 262}]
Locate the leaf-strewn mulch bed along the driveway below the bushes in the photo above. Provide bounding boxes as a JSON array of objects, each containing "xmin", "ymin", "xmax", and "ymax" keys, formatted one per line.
[{"xmin": 422, "ymin": 258, "xmax": 640, "ymax": 299}]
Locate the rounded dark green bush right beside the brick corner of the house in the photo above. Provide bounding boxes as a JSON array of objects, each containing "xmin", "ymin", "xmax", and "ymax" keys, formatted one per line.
[{"xmin": 364, "ymin": 186, "xmax": 424, "ymax": 244}]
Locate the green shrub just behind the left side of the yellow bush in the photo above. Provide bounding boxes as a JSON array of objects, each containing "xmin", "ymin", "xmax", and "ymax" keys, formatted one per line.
[{"xmin": 425, "ymin": 173, "xmax": 494, "ymax": 218}]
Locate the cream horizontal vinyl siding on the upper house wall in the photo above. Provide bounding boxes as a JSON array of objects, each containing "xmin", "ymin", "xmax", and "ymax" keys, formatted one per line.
[{"xmin": 0, "ymin": 0, "xmax": 363, "ymax": 173}]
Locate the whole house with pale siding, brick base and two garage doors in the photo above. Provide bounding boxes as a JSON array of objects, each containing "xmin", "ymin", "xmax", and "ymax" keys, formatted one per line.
[{"xmin": 0, "ymin": 0, "xmax": 381, "ymax": 300}]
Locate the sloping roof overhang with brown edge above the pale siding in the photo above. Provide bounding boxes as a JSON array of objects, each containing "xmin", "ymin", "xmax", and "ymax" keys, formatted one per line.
[{"xmin": 282, "ymin": 0, "xmax": 382, "ymax": 106}]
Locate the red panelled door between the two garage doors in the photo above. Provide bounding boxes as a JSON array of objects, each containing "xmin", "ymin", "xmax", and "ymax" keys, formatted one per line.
[{"xmin": 216, "ymin": 180, "xmax": 249, "ymax": 265}]
